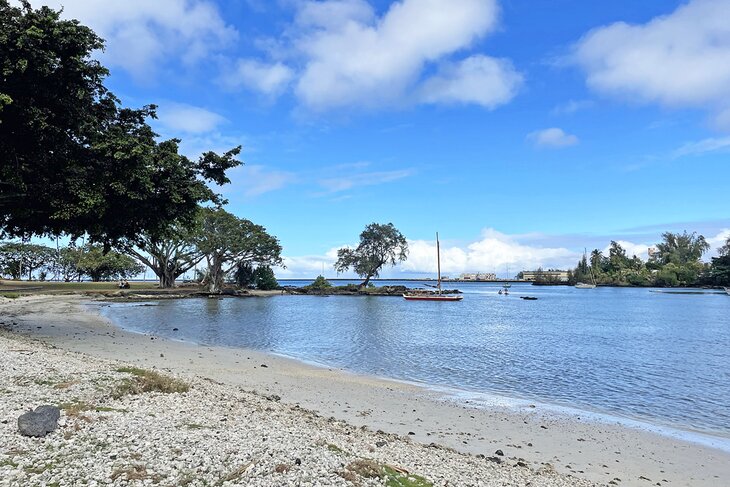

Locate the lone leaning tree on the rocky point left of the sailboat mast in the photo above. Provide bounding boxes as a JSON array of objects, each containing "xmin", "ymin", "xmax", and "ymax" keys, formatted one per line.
[{"xmin": 335, "ymin": 223, "xmax": 408, "ymax": 287}]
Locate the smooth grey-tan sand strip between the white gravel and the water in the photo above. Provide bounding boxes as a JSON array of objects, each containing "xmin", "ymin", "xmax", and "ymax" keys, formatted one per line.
[{"xmin": 0, "ymin": 296, "xmax": 730, "ymax": 486}]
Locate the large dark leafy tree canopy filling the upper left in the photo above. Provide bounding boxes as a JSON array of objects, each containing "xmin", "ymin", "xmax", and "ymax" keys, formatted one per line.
[{"xmin": 0, "ymin": 0, "xmax": 239, "ymax": 242}]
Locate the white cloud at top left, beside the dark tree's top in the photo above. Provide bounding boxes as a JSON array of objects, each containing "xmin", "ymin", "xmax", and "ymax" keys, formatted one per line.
[{"xmin": 28, "ymin": 0, "xmax": 238, "ymax": 81}]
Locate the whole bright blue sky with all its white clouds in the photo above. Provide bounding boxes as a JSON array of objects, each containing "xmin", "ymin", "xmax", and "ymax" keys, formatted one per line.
[{"xmin": 22, "ymin": 0, "xmax": 730, "ymax": 278}]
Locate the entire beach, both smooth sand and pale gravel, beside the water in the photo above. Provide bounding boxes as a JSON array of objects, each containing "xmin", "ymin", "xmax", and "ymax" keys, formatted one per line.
[{"xmin": 0, "ymin": 296, "xmax": 730, "ymax": 486}]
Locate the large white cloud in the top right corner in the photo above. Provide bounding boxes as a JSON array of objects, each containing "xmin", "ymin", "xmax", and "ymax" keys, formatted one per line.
[{"xmin": 573, "ymin": 0, "xmax": 730, "ymax": 124}]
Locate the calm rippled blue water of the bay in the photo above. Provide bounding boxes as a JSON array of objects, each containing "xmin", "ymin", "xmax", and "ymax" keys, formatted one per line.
[{"xmin": 104, "ymin": 283, "xmax": 730, "ymax": 437}]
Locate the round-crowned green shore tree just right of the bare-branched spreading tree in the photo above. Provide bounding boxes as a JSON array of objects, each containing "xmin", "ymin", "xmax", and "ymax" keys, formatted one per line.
[{"xmin": 195, "ymin": 208, "xmax": 282, "ymax": 293}]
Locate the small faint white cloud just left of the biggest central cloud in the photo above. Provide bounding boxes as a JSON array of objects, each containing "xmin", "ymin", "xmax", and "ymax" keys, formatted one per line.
[{"xmin": 221, "ymin": 59, "xmax": 294, "ymax": 96}]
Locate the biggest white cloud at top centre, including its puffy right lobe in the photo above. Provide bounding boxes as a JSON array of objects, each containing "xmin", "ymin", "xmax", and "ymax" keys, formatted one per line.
[{"xmin": 225, "ymin": 0, "xmax": 522, "ymax": 111}]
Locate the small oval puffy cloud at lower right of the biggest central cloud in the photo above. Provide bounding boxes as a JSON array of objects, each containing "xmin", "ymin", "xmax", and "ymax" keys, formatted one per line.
[{"xmin": 422, "ymin": 55, "xmax": 523, "ymax": 108}]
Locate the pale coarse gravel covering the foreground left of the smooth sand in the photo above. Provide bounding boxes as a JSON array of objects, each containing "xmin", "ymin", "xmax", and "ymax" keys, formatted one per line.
[{"xmin": 0, "ymin": 332, "xmax": 594, "ymax": 487}]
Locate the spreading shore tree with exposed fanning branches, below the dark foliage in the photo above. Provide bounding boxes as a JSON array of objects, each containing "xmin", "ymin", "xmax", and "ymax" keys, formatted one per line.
[{"xmin": 120, "ymin": 216, "xmax": 204, "ymax": 288}]
